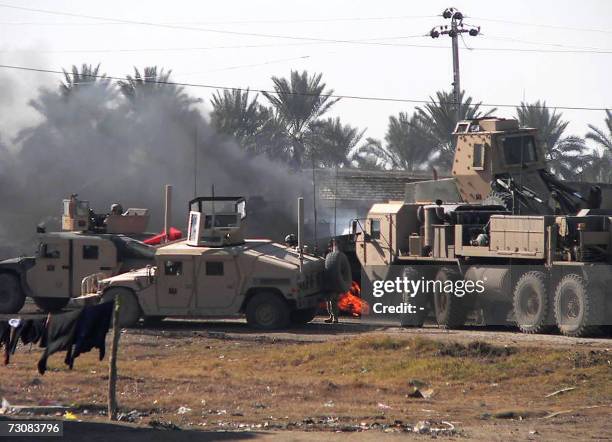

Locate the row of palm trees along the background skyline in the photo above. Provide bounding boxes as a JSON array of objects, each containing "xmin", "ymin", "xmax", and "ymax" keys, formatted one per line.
[{"xmin": 61, "ymin": 65, "xmax": 612, "ymax": 182}]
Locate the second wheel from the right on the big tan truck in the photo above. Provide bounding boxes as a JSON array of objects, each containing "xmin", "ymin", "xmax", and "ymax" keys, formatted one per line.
[{"xmin": 512, "ymin": 271, "xmax": 552, "ymax": 333}]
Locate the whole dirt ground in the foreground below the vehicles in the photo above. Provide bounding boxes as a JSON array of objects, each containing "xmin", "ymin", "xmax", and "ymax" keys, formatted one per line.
[{"xmin": 0, "ymin": 319, "xmax": 612, "ymax": 441}]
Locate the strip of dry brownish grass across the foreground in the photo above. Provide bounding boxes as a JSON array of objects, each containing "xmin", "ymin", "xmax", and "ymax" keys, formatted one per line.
[{"xmin": 0, "ymin": 331, "xmax": 612, "ymax": 435}]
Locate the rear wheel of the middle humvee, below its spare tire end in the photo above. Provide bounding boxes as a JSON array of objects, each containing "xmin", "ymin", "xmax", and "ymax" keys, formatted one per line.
[{"xmin": 246, "ymin": 293, "xmax": 290, "ymax": 330}]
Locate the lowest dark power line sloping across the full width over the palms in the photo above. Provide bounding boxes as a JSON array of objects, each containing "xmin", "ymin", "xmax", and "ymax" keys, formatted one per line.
[{"xmin": 0, "ymin": 64, "xmax": 612, "ymax": 111}]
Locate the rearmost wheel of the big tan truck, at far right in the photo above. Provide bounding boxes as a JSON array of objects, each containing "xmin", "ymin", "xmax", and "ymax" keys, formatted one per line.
[{"xmin": 554, "ymin": 274, "xmax": 605, "ymax": 336}]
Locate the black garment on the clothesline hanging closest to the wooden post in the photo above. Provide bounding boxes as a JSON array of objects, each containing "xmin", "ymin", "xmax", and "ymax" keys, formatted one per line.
[{"xmin": 66, "ymin": 301, "xmax": 115, "ymax": 369}]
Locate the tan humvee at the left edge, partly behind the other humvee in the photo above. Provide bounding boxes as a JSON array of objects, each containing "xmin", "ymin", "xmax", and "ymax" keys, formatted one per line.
[{"xmin": 0, "ymin": 195, "xmax": 155, "ymax": 313}]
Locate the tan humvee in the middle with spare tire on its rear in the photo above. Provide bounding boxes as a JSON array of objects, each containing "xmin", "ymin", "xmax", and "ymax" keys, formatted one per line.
[{"xmin": 81, "ymin": 197, "xmax": 351, "ymax": 329}]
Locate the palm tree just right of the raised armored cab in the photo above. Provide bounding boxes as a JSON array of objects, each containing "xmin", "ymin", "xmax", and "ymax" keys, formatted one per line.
[{"xmin": 516, "ymin": 100, "xmax": 587, "ymax": 179}]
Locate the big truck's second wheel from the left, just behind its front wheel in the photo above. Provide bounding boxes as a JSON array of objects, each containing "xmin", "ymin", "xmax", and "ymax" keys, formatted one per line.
[{"xmin": 434, "ymin": 267, "xmax": 469, "ymax": 328}]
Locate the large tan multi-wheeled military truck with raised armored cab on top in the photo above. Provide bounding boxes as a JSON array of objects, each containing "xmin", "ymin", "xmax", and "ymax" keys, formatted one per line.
[{"xmin": 356, "ymin": 118, "xmax": 612, "ymax": 336}]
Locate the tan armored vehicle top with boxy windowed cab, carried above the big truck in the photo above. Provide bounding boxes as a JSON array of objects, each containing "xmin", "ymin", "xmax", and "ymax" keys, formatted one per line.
[{"xmin": 405, "ymin": 117, "xmax": 612, "ymax": 215}]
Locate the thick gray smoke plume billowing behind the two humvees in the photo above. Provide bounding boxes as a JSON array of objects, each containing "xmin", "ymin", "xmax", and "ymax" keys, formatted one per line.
[{"xmin": 0, "ymin": 68, "xmax": 312, "ymax": 257}]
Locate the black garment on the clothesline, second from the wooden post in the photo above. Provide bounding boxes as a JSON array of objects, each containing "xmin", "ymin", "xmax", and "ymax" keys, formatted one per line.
[{"xmin": 38, "ymin": 310, "xmax": 81, "ymax": 374}]
